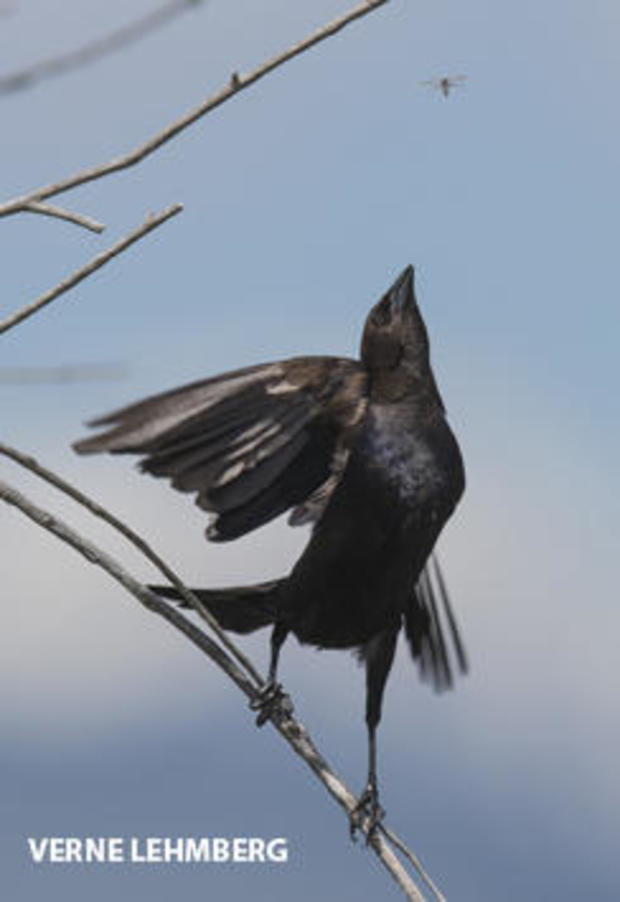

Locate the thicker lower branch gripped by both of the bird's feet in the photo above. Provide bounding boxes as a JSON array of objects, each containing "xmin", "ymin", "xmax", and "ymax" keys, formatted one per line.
[{"xmin": 0, "ymin": 481, "xmax": 432, "ymax": 902}]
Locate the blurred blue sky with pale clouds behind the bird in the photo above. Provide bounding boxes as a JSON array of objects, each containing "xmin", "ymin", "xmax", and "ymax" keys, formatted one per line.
[{"xmin": 0, "ymin": 0, "xmax": 620, "ymax": 902}]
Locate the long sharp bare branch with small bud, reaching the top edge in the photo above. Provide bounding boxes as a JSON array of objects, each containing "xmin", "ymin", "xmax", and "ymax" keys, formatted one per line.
[{"xmin": 0, "ymin": 0, "xmax": 388, "ymax": 216}]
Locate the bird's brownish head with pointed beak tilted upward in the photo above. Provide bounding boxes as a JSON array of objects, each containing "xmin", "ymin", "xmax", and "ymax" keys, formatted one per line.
[{"xmin": 361, "ymin": 266, "xmax": 441, "ymax": 404}]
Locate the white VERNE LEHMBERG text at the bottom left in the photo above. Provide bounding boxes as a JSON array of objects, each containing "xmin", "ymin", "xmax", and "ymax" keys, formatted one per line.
[{"xmin": 28, "ymin": 836, "xmax": 288, "ymax": 864}]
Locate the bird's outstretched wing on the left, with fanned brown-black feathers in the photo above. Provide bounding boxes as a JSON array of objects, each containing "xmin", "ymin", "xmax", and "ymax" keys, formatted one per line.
[{"xmin": 74, "ymin": 357, "xmax": 366, "ymax": 541}]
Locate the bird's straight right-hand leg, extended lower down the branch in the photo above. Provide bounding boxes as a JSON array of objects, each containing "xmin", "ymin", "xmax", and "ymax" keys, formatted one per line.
[{"xmin": 351, "ymin": 621, "xmax": 400, "ymax": 840}]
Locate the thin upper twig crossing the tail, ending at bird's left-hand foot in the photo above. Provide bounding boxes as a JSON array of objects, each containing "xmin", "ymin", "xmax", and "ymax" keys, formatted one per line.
[{"xmin": 0, "ymin": 442, "xmax": 264, "ymax": 686}]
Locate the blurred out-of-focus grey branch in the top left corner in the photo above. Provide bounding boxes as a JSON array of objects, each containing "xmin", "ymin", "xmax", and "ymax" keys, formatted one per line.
[{"xmin": 0, "ymin": 0, "xmax": 206, "ymax": 94}]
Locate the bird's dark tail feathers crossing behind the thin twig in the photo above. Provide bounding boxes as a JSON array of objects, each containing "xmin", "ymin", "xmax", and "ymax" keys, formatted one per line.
[{"xmin": 149, "ymin": 579, "xmax": 284, "ymax": 633}]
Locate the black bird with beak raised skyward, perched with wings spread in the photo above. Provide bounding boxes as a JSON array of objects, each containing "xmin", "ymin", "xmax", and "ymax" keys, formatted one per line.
[{"xmin": 74, "ymin": 266, "xmax": 466, "ymax": 829}]
